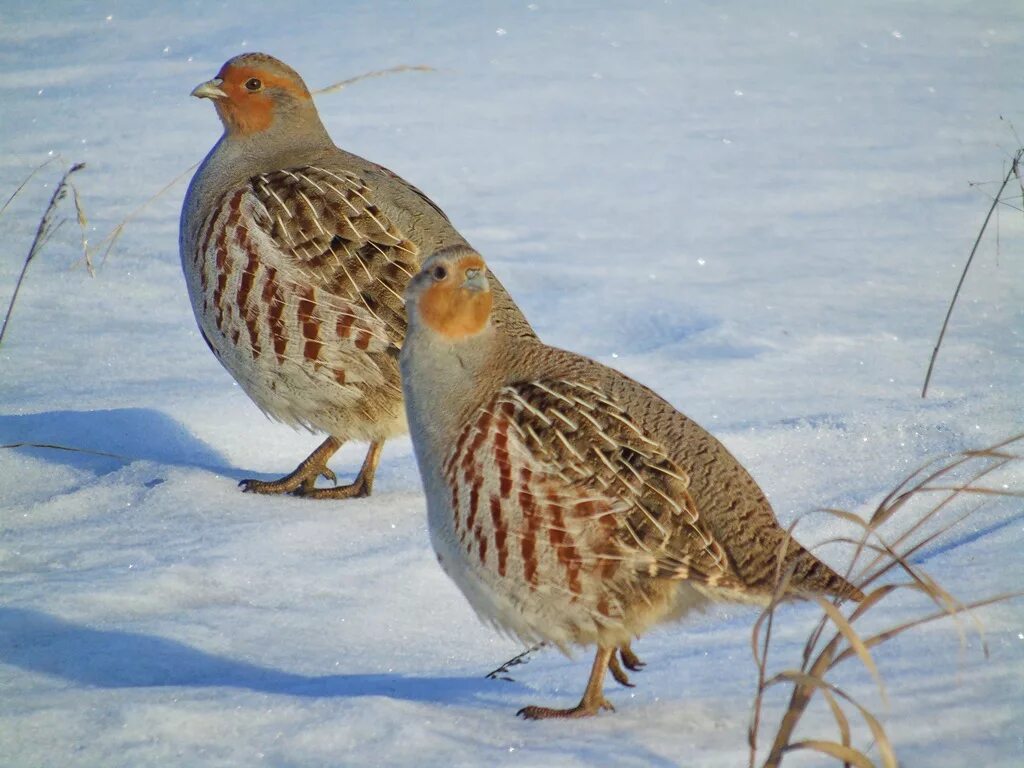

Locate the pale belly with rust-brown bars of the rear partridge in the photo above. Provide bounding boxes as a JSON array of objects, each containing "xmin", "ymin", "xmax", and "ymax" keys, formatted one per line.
[{"xmin": 183, "ymin": 195, "xmax": 407, "ymax": 440}]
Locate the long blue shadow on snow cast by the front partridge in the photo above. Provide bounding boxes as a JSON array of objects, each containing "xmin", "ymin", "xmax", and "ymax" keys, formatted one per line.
[{"xmin": 0, "ymin": 607, "xmax": 494, "ymax": 703}]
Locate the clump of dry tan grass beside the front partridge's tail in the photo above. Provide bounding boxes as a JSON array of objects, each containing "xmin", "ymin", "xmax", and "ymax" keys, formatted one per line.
[{"xmin": 748, "ymin": 435, "xmax": 1024, "ymax": 768}]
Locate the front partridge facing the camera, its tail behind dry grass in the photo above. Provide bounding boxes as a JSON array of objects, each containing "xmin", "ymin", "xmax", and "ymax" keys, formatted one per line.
[{"xmin": 399, "ymin": 245, "xmax": 863, "ymax": 720}]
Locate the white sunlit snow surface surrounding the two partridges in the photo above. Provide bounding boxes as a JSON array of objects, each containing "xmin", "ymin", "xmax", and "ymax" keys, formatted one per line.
[{"xmin": 0, "ymin": 0, "xmax": 1024, "ymax": 767}]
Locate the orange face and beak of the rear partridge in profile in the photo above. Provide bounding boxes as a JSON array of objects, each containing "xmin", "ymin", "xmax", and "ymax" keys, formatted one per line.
[{"xmin": 193, "ymin": 59, "xmax": 311, "ymax": 136}]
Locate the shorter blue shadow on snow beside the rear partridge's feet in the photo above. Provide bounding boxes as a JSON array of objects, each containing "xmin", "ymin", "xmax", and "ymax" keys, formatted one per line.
[{"xmin": 0, "ymin": 408, "xmax": 231, "ymax": 474}]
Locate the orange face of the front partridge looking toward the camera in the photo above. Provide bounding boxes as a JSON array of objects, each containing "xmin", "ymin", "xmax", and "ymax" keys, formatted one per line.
[{"xmin": 418, "ymin": 253, "xmax": 493, "ymax": 341}]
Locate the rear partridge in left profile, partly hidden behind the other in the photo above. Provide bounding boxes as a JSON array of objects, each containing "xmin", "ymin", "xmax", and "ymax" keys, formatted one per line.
[{"xmin": 179, "ymin": 53, "xmax": 534, "ymax": 499}]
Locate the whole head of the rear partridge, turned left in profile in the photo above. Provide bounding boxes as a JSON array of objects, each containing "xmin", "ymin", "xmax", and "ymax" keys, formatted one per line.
[{"xmin": 191, "ymin": 53, "xmax": 319, "ymax": 136}]
